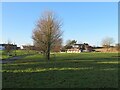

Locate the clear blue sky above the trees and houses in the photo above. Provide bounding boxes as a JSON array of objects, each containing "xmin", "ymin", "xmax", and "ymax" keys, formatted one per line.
[{"xmin": 0, "ymin": 2, "xmax": 118, "ymax": 46}]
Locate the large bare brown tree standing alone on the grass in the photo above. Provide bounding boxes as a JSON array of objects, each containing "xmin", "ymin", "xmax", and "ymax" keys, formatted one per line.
[{"xmin": 32, "ymin": 11, "xmax": 62, "ymax": 60}]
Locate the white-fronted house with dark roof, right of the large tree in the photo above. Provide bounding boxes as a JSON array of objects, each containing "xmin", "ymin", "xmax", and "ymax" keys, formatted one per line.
[{"xmin": 67, "ymin": 43, "xmax": 92, "ymax": 53}]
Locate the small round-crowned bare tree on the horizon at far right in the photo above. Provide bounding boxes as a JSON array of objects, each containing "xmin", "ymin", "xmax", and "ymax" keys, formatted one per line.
[{"xmin": 102, "ymin": 37, "xmax": 114, "ymax": 51}]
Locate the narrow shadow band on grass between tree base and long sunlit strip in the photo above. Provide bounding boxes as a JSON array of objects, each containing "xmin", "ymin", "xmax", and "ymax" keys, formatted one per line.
[{"xmin": 2, "ymin": 59, "xmax": 119, "ymax": 71}]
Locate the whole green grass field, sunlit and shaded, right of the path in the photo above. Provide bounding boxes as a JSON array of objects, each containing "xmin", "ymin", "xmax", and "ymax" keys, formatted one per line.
[{"xmin": 2, "ymin": 53, "xmax": 119, "ymax": 88}]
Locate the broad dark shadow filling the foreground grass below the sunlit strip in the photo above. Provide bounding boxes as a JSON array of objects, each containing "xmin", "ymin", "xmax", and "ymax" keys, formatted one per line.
[{"xmin": 2, "ymin": 70, "xmax": 118, "ymax": 88}]
